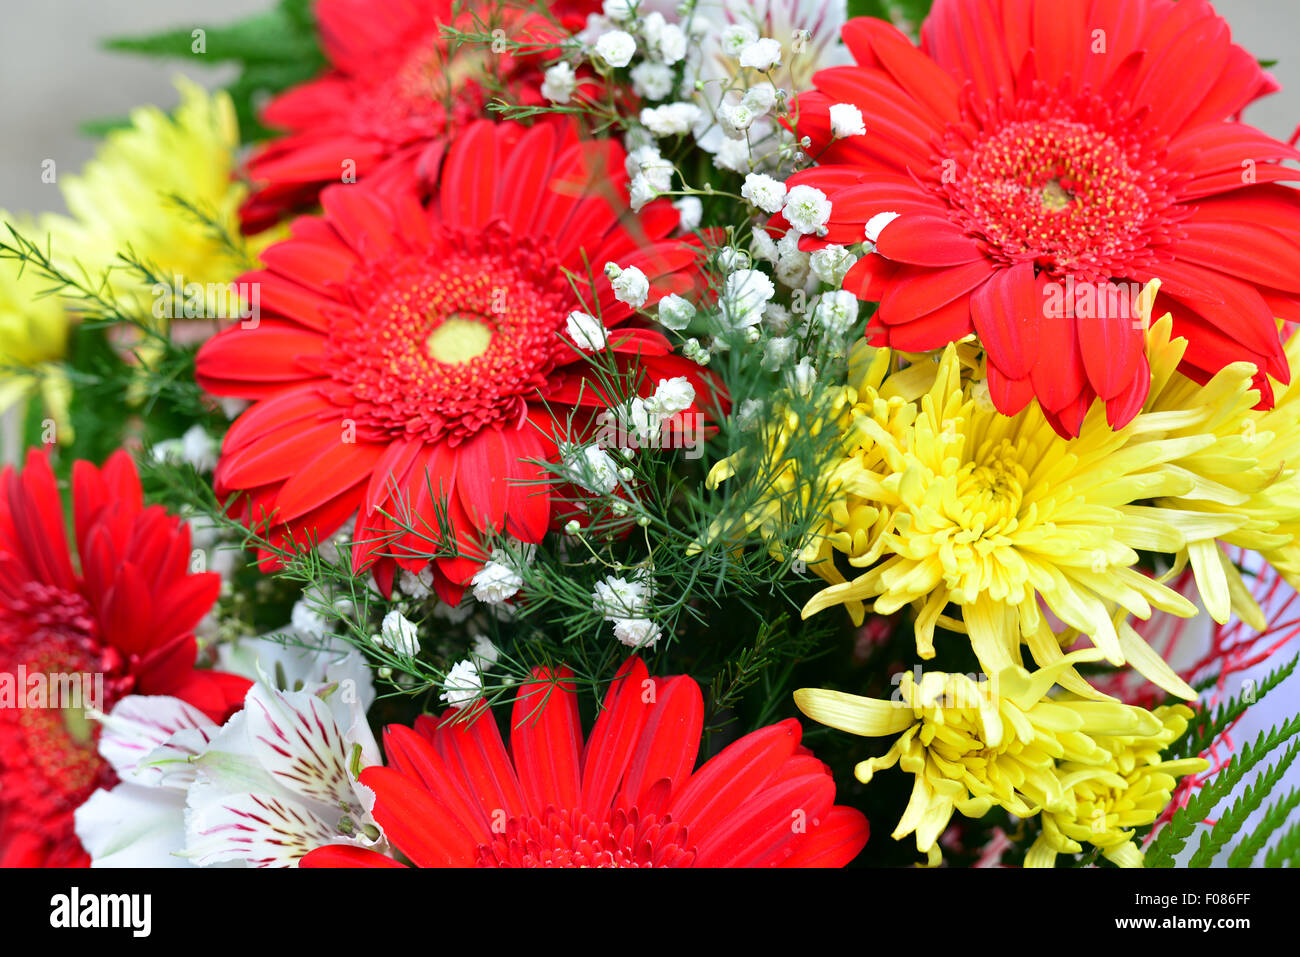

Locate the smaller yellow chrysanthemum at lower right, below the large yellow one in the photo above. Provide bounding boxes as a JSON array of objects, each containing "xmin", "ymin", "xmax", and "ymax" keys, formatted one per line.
[{"xmin": 794, "ymin": 649, "xmax": 1162, "ymax": 863}]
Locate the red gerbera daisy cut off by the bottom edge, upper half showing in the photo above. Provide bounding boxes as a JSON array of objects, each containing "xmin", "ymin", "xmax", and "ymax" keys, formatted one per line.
[{"xmin": 302, "ymin": 658, "xmax": 867, "ymax": 867}]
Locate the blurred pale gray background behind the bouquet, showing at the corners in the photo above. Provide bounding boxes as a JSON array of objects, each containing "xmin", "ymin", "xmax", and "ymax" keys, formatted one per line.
[{"xmin": 0, "ymin": 0, "xmax": 1300, "ymax": 859}]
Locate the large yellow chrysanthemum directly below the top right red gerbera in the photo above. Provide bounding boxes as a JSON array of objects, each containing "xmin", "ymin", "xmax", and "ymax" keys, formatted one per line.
[{"xmin": 710, "ymin": 321, "xmax": 1240, "ymax": 698}]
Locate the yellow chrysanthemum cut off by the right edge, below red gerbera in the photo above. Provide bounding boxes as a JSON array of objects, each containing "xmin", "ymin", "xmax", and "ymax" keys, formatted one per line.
[{"xmin": 1144, "ymin": 306, "xmax": 1300, "ymax": 631}]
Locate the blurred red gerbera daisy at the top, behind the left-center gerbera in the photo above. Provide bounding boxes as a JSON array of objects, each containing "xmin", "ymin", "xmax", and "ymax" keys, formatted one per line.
[{"xmin": 242, "ymin": 0, "xmax": 597, "ymax": 231}]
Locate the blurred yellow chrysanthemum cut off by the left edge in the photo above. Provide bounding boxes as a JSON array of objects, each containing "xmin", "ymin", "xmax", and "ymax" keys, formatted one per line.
[{"xmin": 0, "ymin": 209, "xmax": 70, "ymax": 434}]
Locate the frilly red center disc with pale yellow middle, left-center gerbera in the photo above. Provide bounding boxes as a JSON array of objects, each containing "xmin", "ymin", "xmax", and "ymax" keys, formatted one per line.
[{"xmin": 325, "ymin": 224, "xmax": 572, "ymax": 442}]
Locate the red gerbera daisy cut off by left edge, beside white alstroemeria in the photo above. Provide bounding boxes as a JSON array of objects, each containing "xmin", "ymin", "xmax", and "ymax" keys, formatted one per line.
[{"xmin": 0, "ymin": 450, "xmax": 248, "ymax": 866}]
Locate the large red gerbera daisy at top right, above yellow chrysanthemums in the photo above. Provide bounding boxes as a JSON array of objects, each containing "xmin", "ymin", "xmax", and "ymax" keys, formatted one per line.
[{"xmin": 792, "ymin": 0, "xmax": 1300, "ymax": 436}]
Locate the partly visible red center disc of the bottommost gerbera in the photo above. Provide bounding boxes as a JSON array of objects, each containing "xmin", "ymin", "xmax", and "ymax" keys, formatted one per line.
[{"xmin": 477, "ymin": 807, "xmax": 696, "ymax": 867}]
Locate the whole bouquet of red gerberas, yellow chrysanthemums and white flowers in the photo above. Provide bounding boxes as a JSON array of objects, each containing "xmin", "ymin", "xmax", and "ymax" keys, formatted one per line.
[{"xmin": 0, "ymin": 0, "xmax": 1300, "ymax": 867}]
